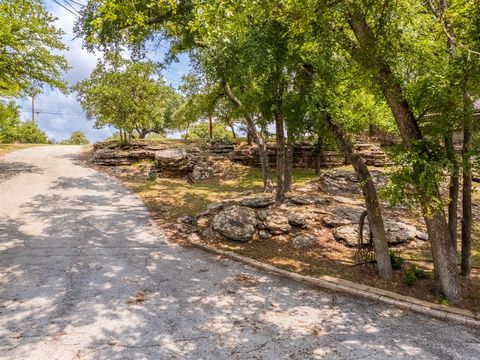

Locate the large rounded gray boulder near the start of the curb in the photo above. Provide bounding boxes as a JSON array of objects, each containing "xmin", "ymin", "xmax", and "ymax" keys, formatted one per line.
[{"xmin": 212, "ymin": 205, "xmax": 257, "ymax": 241}]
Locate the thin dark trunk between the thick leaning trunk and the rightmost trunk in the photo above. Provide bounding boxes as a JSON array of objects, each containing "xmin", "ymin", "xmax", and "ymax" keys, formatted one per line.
[{"xmin": 445, "ymin": 134, "xmax": 460, "ymax": 258}]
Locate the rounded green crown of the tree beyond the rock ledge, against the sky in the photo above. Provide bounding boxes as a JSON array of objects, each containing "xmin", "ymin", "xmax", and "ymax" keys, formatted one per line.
[{"xmin": 73, "ymin": 53, "xmax": 181, "ymax": 138}]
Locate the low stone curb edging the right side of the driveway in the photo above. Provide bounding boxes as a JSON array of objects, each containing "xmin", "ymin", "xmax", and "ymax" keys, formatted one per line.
[{"xmin": 190, "ymin": 242, "xmax": 480, "ymax": 327}]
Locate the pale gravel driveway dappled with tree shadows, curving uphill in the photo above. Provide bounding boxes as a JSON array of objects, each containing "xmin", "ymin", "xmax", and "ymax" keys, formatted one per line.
[{"xmin": 0, "ymin": 146, "xmax": 480, "ymax": 360}]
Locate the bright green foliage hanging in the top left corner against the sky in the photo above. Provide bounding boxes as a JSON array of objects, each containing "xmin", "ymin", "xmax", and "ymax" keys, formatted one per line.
[{"xmin": 0, "ymin": 0, "xmax": 68, "ymax": 96}]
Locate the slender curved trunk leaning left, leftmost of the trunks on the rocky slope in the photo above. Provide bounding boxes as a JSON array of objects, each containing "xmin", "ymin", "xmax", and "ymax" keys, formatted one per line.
[{"xmin": 223, "ymin": 82, "xmax": 273, "ymax": 192}]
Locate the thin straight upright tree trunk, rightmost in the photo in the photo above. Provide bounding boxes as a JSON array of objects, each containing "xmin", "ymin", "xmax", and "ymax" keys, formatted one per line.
[{"xmin": 461, "ymin": 93, "xmax": 472, "ymax": 276}]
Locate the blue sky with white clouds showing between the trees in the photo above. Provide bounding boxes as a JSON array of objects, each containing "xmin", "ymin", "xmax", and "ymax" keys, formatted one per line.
[{"xmin": 18, "ymin": 0, "xmax": 189, "ymax": 142}]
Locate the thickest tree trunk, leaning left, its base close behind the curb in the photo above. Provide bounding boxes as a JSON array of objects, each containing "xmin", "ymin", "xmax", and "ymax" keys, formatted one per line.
[{"xmin": 347, "ymin": 11, "xmax": 462, "ymax": 304}]
